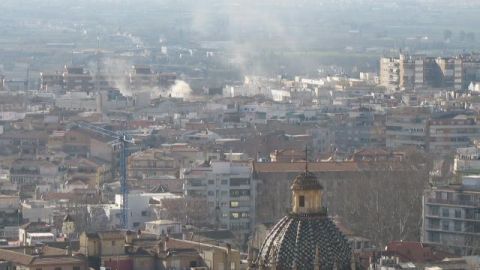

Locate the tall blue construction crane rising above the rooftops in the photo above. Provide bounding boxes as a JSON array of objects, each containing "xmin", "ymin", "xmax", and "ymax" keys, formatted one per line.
[{"xmin": 75, "ymin": 121, "xmax": 135, "ymax": 229}]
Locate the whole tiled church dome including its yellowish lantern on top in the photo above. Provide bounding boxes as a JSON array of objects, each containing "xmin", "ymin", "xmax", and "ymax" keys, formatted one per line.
[{"xmin": 249, "ymin": 168, "xmax": 356, "ymax": 270}]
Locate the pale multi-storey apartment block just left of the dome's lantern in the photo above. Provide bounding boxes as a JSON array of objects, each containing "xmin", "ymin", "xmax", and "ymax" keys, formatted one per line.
[{"xmin": 181, "ymin": 161, "xmax": 256, "ymax": 233}]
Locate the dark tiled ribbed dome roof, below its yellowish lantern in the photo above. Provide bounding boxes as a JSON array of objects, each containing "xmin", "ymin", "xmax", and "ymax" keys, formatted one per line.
[{"xmin": 255, "ymin": 213, "xmax": 351, "ymax": 270}]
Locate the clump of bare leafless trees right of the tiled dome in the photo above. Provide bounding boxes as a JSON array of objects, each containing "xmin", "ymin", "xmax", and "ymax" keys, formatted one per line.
[{"xmin": 334, "ymin": 150, "xmax": 429, "ymax": 246}]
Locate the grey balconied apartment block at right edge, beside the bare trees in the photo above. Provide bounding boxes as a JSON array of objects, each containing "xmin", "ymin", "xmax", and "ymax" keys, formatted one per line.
[{"xmin": 422, "ymin": 177, "xmax": 480, "ymax": 255}]
